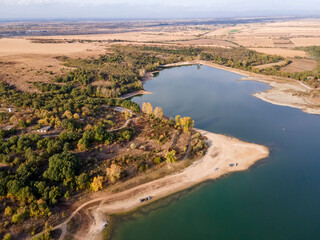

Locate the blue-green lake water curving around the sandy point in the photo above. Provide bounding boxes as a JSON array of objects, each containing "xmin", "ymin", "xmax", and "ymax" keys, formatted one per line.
[{"xmin": 113, "ymin": 66, "xmax": 320, "ymax": 240}]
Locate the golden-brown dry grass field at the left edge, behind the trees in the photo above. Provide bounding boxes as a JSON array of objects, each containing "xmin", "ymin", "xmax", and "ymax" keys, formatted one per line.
[{"xmin": 0, "ymin": 38, "xmax": 106, "ymax": 92}]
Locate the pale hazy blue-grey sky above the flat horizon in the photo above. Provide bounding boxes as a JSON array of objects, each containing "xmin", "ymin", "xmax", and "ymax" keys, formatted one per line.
[{"xmin": 0, "ymin": 0, "xmax": 320, "ymax": 19}]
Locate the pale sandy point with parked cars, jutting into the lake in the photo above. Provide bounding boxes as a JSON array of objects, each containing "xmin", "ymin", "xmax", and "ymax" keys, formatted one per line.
[{"xmin": 82, "ymin": 130, "xmax": 269, "ymax": 239}]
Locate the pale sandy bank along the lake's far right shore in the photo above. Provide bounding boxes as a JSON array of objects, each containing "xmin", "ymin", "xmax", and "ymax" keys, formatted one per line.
[{"xmin": 162, "ymin": 60, "xmax": 320, "ymax": 114}]
